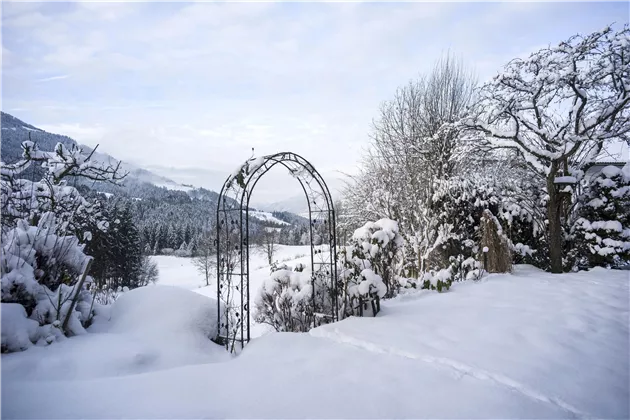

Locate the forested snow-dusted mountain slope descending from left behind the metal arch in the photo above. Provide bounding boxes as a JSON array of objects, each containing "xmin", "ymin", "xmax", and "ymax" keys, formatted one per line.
[{"xmin": 0, "ymin": 112, "xmax": 308, "ymax": 249}]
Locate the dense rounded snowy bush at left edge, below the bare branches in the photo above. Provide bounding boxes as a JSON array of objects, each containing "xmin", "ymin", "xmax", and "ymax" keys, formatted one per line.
[{"xmin": 0, "ymin": 212, "xmax": 92, "ymax": 348}]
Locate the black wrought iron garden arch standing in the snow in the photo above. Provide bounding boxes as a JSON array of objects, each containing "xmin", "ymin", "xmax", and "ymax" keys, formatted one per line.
[{"xmin": 216, "ymin": 152, "xmax": 339, "ymax": 351}]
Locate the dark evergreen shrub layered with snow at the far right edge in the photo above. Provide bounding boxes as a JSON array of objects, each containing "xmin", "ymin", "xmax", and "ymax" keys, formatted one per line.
[{"xmin": 569, "ymin": 164, "xmax": 630, "ymax": 269}]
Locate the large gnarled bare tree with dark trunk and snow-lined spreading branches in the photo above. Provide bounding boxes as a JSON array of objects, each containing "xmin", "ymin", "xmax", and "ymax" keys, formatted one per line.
[{"xmin": 465, "ymin": 25, "xmax": 630, "ymax": 273}]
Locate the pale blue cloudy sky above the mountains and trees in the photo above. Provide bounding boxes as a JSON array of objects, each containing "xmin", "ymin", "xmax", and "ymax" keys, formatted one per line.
[{"xmin": 0, "ymin": 0, "xmax": 630, "ymax": 206}]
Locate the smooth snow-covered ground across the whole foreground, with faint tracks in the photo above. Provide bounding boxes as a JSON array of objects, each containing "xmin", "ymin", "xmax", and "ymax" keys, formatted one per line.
[{"xmin": 0, "ymin": 260, "xmax": 630, "ymax": 419}]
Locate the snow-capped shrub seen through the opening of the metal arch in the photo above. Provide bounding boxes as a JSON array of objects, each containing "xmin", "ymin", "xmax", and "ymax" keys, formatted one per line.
[{"xmin": 255, "ymin": 269, "xmax": 315, "ymax": 332}]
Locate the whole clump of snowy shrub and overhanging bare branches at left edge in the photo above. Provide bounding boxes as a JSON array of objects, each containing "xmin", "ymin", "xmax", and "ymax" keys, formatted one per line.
[{"xmin": 0, "ymin": 141, "xmax": 126, "ymax": 351}]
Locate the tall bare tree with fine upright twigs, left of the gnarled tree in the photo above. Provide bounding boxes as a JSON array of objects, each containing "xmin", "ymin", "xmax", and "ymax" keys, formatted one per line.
[{"xmin": 344, "ymin": 54, "xmax": 476, "ymax": 274}]
